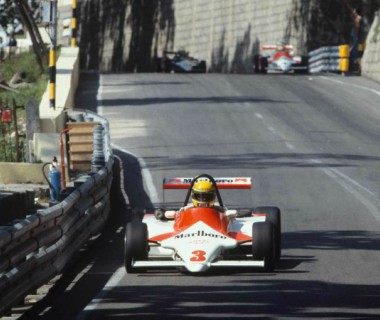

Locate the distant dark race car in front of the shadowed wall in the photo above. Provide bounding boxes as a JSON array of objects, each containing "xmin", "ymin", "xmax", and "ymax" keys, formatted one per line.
[{"xmin": 157, "ymin": 50, "xmax": 206, "ymax": 73}]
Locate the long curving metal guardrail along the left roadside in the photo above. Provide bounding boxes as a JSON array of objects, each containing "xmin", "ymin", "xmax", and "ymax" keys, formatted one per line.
[{"xmin": 0, "ymin": 110, "xmax": 113, "ymax": 316}]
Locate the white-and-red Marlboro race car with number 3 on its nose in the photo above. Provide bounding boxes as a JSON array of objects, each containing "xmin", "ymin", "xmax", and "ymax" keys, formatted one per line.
[{"xmin": 124, "ymin": 174, "xmax": 281, "ymax": 273}]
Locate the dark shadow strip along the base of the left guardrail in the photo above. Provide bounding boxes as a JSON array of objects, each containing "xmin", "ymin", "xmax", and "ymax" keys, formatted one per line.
[{"xmin": 20, "ymin": 152, "xmax": 151, "ymax": 319}]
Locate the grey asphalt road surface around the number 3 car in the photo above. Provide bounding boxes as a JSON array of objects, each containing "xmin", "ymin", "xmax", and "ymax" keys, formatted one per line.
[{"xmin": 22, "ymin": 74, "xmax": 380, "ymax": 319}]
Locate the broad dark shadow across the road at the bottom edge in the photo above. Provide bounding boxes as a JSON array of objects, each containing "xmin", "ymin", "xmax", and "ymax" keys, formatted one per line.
[{"xmin": 76, "ymin": 275, "xmax": 380, "ymax": 319}]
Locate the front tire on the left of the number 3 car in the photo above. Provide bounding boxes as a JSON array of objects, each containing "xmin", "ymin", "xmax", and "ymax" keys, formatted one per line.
[{"xmin": 124, "ymin": 221, "xmax": 148, "ymax": 273}]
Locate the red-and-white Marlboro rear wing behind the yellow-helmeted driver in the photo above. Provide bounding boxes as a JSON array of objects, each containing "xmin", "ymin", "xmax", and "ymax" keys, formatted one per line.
[{"xmin": 162, "ymin": 177, "xmax": 252, "ymax": 190}]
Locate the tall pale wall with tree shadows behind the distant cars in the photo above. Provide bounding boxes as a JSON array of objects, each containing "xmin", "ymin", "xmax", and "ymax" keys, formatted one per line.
[{"xmin": 79, "ymin": 0, "xmax": 306, "ymax": 72}]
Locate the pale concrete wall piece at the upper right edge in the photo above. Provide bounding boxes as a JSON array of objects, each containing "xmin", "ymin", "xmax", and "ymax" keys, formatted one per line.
[{"xmin": 362, "ymin": 11, "xmax": 380, "ymax": 82}]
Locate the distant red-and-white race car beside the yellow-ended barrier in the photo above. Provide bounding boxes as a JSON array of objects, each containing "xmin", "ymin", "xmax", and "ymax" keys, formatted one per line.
[{"xmin": 254, "ymin": 45, "xmax": 308, "ymax": 73}]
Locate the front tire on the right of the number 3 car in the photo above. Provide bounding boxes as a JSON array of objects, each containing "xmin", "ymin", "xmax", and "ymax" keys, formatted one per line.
[{"xmin": 252, "ymin": 222, "xmax": 276, "ymax": 272}]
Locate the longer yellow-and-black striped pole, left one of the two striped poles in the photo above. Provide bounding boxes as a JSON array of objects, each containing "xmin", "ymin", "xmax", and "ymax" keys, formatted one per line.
[{"xmin": 49, "ymin": 0, "xmax": 57, "ymax": 109}]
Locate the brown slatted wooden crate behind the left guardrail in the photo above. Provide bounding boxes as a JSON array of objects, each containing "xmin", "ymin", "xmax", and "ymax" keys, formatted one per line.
[{"xmin": 67, "ymin": 122, "xmax": 99, "ymax": 171}]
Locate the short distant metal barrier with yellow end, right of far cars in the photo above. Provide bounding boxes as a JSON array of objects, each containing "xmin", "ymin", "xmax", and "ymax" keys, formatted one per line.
[{"xmin": 309, "ymin": 45, "xmax": 350, "ymax": 73}]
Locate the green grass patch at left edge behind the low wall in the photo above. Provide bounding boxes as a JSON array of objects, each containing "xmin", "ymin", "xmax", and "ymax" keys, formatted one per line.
[{"xmin": 0, "ymin": 52, "xmax": 49, "ymax": 162}]
